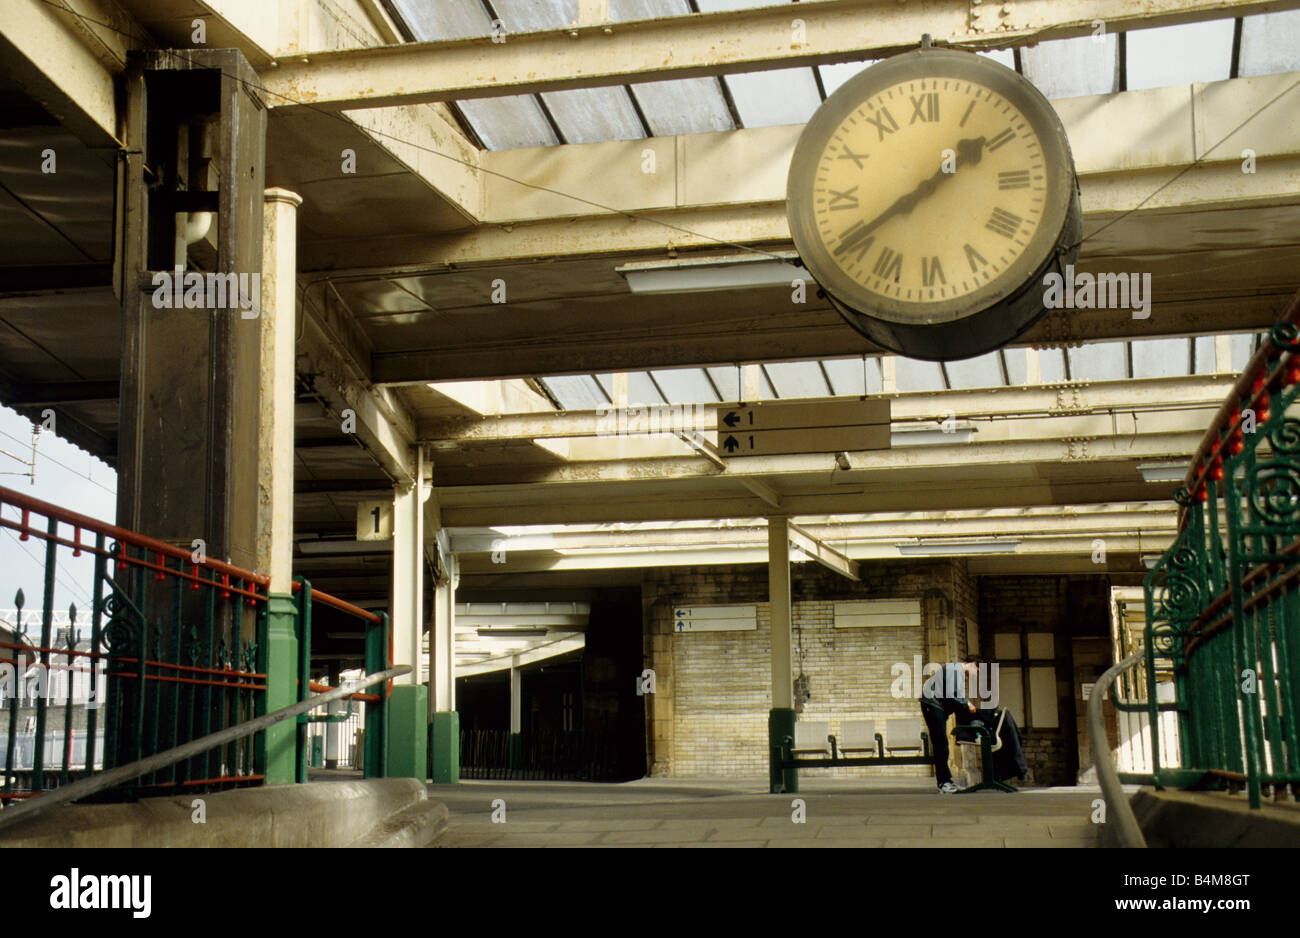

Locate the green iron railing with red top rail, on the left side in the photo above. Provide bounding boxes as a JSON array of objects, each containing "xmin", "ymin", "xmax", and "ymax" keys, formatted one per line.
[{"xmin": 0, "ymin": 487, "xmax": 391, "ymax": 807}]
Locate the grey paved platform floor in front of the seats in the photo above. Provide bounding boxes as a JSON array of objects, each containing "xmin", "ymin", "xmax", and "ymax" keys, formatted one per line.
[{"xmin": 429, "ymin": 778, "xmax": 1101, "ymax": 847}]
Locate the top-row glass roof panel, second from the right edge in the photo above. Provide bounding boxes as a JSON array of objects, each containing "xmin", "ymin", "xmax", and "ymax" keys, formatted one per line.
[{"xmin": 1127, "ymin": 19, "xmax": 1232, "ymax": 91}]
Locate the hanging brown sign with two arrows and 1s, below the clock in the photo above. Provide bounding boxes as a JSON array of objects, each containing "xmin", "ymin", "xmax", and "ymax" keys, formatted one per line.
[{"xmin": 718, "ymin": 398, "xmax": 889, "ymax": 456}]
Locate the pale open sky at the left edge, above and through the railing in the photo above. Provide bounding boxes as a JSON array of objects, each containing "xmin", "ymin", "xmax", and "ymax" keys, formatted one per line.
[{"xmin": 0, "ymin": 407, "xmax": 117, "ymax": 634}]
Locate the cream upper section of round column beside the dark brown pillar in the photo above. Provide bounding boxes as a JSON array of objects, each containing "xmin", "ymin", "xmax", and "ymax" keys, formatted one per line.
[{"xmin": 256, "ymin": 188, "xmax": 303, "ymax": 595}]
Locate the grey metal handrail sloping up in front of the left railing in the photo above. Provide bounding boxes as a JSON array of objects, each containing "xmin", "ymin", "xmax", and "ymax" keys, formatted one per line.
[{"xmin": 0, "ymin": 664, "xmax": 411, "ymax": 830}]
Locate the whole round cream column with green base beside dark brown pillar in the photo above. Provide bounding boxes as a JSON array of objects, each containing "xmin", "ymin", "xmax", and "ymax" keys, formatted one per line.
[{"xmin": 262, "ymin": 188, "xmax": 307, "ymax": 785}]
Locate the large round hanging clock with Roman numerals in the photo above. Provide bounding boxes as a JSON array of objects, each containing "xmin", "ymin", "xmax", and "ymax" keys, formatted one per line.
[{"xmin": 788, "ymin": 49, "xmax": 1079, "ymax": 360}]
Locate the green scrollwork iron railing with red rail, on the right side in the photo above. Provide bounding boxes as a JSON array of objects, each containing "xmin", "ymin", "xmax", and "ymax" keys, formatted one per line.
[{"xmin": 1133, "ymin": 301, "xmax": 1300, "ymax": 808}]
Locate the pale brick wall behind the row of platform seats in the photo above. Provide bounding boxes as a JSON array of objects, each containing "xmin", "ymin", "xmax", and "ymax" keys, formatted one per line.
[{"xmin": 642, "ymin": 560, "xmax": 978, "ymax": 778}]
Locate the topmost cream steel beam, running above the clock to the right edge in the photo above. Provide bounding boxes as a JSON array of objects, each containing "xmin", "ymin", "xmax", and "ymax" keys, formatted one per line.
[{"xmin": 263, "ymin": 0, "xmax": 1300, "ymax": 108}]
